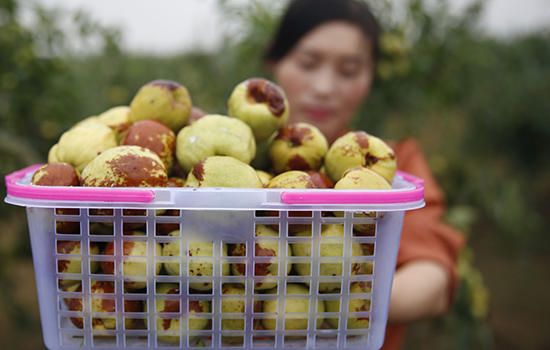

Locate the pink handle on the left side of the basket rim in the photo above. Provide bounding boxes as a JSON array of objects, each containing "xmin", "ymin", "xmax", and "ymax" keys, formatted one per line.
[{"xmin": 5, "ymin": 164, "xmax": 155, "ymax": 203}]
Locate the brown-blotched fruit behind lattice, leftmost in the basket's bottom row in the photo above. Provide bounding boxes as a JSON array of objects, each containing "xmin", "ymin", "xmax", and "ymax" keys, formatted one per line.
[{"xmin": 65, "ymin": 281, "xmax": 143, "ymax": 330}]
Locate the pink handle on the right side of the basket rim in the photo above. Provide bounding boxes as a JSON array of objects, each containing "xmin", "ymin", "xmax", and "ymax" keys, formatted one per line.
[{"xmin": 281, "ymin": 171, "xmax": 424, "ymax": 204}]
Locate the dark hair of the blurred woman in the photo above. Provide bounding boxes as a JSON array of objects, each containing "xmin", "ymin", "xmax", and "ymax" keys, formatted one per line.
[{"xmin": 264, "ymin": 0, "xmax": 379, "ymax": 64}]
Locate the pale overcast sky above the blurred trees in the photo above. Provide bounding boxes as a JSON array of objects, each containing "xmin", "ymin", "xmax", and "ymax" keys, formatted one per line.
[{"xmin": 28, "ymin": 0, "xmax": 550, "ymax": 54}]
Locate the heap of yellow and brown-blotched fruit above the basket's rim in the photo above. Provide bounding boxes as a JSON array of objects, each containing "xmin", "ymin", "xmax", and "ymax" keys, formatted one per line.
[{"xmin": 32, "ymin": 78, "xmax": 396, "ymax": 189}]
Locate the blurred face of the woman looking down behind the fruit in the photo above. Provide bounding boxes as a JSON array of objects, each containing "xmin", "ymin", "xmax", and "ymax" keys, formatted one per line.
[{"xmin": 273, "ymin": 21, "xmax": 374, "ymax": 142}]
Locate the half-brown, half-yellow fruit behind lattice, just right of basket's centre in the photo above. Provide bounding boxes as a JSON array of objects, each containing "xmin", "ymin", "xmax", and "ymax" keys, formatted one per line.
[{"xmin": 229, "ymin": 225, "xmax": 292, "ymax": 290}]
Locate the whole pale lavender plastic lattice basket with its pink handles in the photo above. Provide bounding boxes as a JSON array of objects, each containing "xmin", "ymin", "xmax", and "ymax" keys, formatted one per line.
[{"xmin": 5, "ymin": 166, "xmax": 424, "ymax": 349}]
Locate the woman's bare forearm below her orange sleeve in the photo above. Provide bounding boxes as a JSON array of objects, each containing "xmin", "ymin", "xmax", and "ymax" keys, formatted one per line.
[{"xmin": 388, "ymin": 260, "xmax": 450, "ymax": 323}]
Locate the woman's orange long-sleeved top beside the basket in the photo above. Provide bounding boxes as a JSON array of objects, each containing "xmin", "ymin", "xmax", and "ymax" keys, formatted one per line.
[{"xmin": 382, "ymin": 139, "xmax": 464, "ymax": 350}]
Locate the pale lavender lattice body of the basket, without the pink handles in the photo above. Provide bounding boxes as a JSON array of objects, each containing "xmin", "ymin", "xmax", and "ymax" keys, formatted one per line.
[{"xmin": 6, "ymin": 167, "xmax": 423, "ymax": 349}]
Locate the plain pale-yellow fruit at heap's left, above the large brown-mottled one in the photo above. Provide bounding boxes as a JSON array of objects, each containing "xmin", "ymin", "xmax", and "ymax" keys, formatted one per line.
[{"xmin": 51, "ymin": 121, "xmax": 117, "ymax": 172}]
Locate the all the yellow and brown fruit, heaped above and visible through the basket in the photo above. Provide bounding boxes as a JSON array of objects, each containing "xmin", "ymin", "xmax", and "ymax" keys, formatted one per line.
[{"xmin": 36, "ymin": 78, "xmax": 396, "ymax": 343}]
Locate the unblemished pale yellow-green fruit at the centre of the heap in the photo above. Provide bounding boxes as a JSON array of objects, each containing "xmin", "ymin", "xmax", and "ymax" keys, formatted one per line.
[{"xmin": 176, "ymin": 114, "xmax": 256, "ymax": 172}]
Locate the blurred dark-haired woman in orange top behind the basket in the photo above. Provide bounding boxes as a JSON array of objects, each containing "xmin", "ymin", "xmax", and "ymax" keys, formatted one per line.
[{"xmin": 265, "ymin": 0, "xmax": 463, "ymax": 349}]
